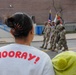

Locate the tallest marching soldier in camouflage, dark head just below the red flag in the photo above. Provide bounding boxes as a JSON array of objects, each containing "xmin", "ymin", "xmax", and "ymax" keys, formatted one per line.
[{"xmin": 49, "ymin": 20, "xmax": 62, "ymax": 51}]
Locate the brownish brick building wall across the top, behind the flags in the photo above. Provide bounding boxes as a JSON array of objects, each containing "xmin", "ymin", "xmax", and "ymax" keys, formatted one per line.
[{"xmin": 0, "ymin": 0, "xmax": 76, "ymax": 24}]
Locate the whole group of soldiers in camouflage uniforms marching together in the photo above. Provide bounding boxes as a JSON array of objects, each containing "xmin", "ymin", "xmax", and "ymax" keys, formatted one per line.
[{"xmin": 41, "ymin": 20, "xmax": 68, "ymax": 51}]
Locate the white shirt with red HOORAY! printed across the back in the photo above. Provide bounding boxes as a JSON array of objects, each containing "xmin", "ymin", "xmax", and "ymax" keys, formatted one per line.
[{"xmin": 0, "ymin": 44, "xmax": 55, "ymax": 75}]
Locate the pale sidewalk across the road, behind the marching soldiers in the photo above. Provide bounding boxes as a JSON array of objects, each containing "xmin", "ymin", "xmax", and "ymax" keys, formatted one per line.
[{"xmin": 0, "ymin": 33, "xmax": 76, "ymax": 43}]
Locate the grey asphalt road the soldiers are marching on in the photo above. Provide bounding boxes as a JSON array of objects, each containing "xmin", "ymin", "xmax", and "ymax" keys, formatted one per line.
[{"xmin": 0, "ymin": 40, "xmax": 76, "ymax": 58}]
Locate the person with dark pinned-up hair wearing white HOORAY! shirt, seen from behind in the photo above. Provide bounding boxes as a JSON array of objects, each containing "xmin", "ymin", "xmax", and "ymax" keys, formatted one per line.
[{"xmin": 0, "ymin": 13, "xmax": 54, "ymax": 75}]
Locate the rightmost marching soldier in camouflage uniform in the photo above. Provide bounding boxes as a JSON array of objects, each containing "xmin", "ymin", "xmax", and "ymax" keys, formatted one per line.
[{"xmin": 57, "ymin": 26, "xmax": 68, "ymax": 51}]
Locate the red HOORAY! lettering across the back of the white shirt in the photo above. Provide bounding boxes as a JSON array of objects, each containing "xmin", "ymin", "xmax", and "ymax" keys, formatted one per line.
[{"xmin": 0, "ymin": 51, "xmax": 40, "ymax": 64}]
